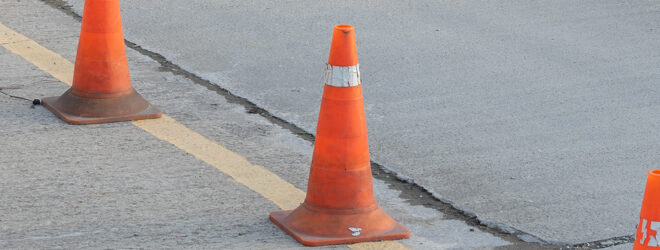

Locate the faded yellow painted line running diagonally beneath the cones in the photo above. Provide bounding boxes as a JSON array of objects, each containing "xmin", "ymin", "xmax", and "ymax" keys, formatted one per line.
[{"xmin": 0, "ymin": 23, "xmax": 410, "ymax": 250}]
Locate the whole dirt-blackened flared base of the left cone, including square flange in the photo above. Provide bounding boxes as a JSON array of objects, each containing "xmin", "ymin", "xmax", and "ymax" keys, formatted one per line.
[{"xmin": 41, "ymin": 89, "xmax": 163, "ymax": 124}]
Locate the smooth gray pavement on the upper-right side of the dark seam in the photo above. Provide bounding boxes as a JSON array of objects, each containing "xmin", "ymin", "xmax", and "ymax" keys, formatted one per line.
[{"xmin": 56, "ymin": 0, "xmax": 660, "ymax": 243}]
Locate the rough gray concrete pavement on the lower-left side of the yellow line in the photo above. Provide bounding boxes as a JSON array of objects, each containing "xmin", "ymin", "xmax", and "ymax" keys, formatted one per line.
[{"xmin": 0, "ymin": 48, "xmax": 322, "ymax": 249}]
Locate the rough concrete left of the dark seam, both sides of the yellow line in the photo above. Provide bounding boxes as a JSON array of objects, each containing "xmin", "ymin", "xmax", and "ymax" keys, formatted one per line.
[{"xmin": 0, "ymin": 0, "xmax": 511, "ymax": 249}]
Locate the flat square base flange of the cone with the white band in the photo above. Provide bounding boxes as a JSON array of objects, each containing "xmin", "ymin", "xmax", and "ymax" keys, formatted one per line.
[{"xmin": 270, "ymin": 210, "xmax": 410, "ymax": 246}]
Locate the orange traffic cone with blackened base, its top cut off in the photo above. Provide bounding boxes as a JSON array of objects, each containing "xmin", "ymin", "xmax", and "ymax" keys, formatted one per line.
[{"xmin": 42, "ymin": 0, "xmax": 161, "ymax": 124}]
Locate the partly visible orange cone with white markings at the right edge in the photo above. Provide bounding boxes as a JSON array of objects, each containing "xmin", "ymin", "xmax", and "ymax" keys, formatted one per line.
[{"xmin": 633, "ymin": 169, "xmax": 660, "ymax": 250}]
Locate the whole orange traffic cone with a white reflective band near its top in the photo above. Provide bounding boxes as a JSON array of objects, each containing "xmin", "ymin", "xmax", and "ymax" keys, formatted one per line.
[{"xmin": 270, "ymin": 25, "xmax": 410, "ymax": 246}]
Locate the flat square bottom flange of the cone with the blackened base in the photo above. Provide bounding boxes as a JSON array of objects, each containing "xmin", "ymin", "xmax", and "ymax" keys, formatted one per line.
[{"xmin": 41, "ymin": 96, "xmax": 163, "ymax": 125}]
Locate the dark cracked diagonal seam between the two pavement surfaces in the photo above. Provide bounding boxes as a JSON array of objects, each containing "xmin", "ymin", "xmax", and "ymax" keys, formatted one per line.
[{"xmin": 32, "ymin": 0, "xmax": 634, "ymax": 249}]
